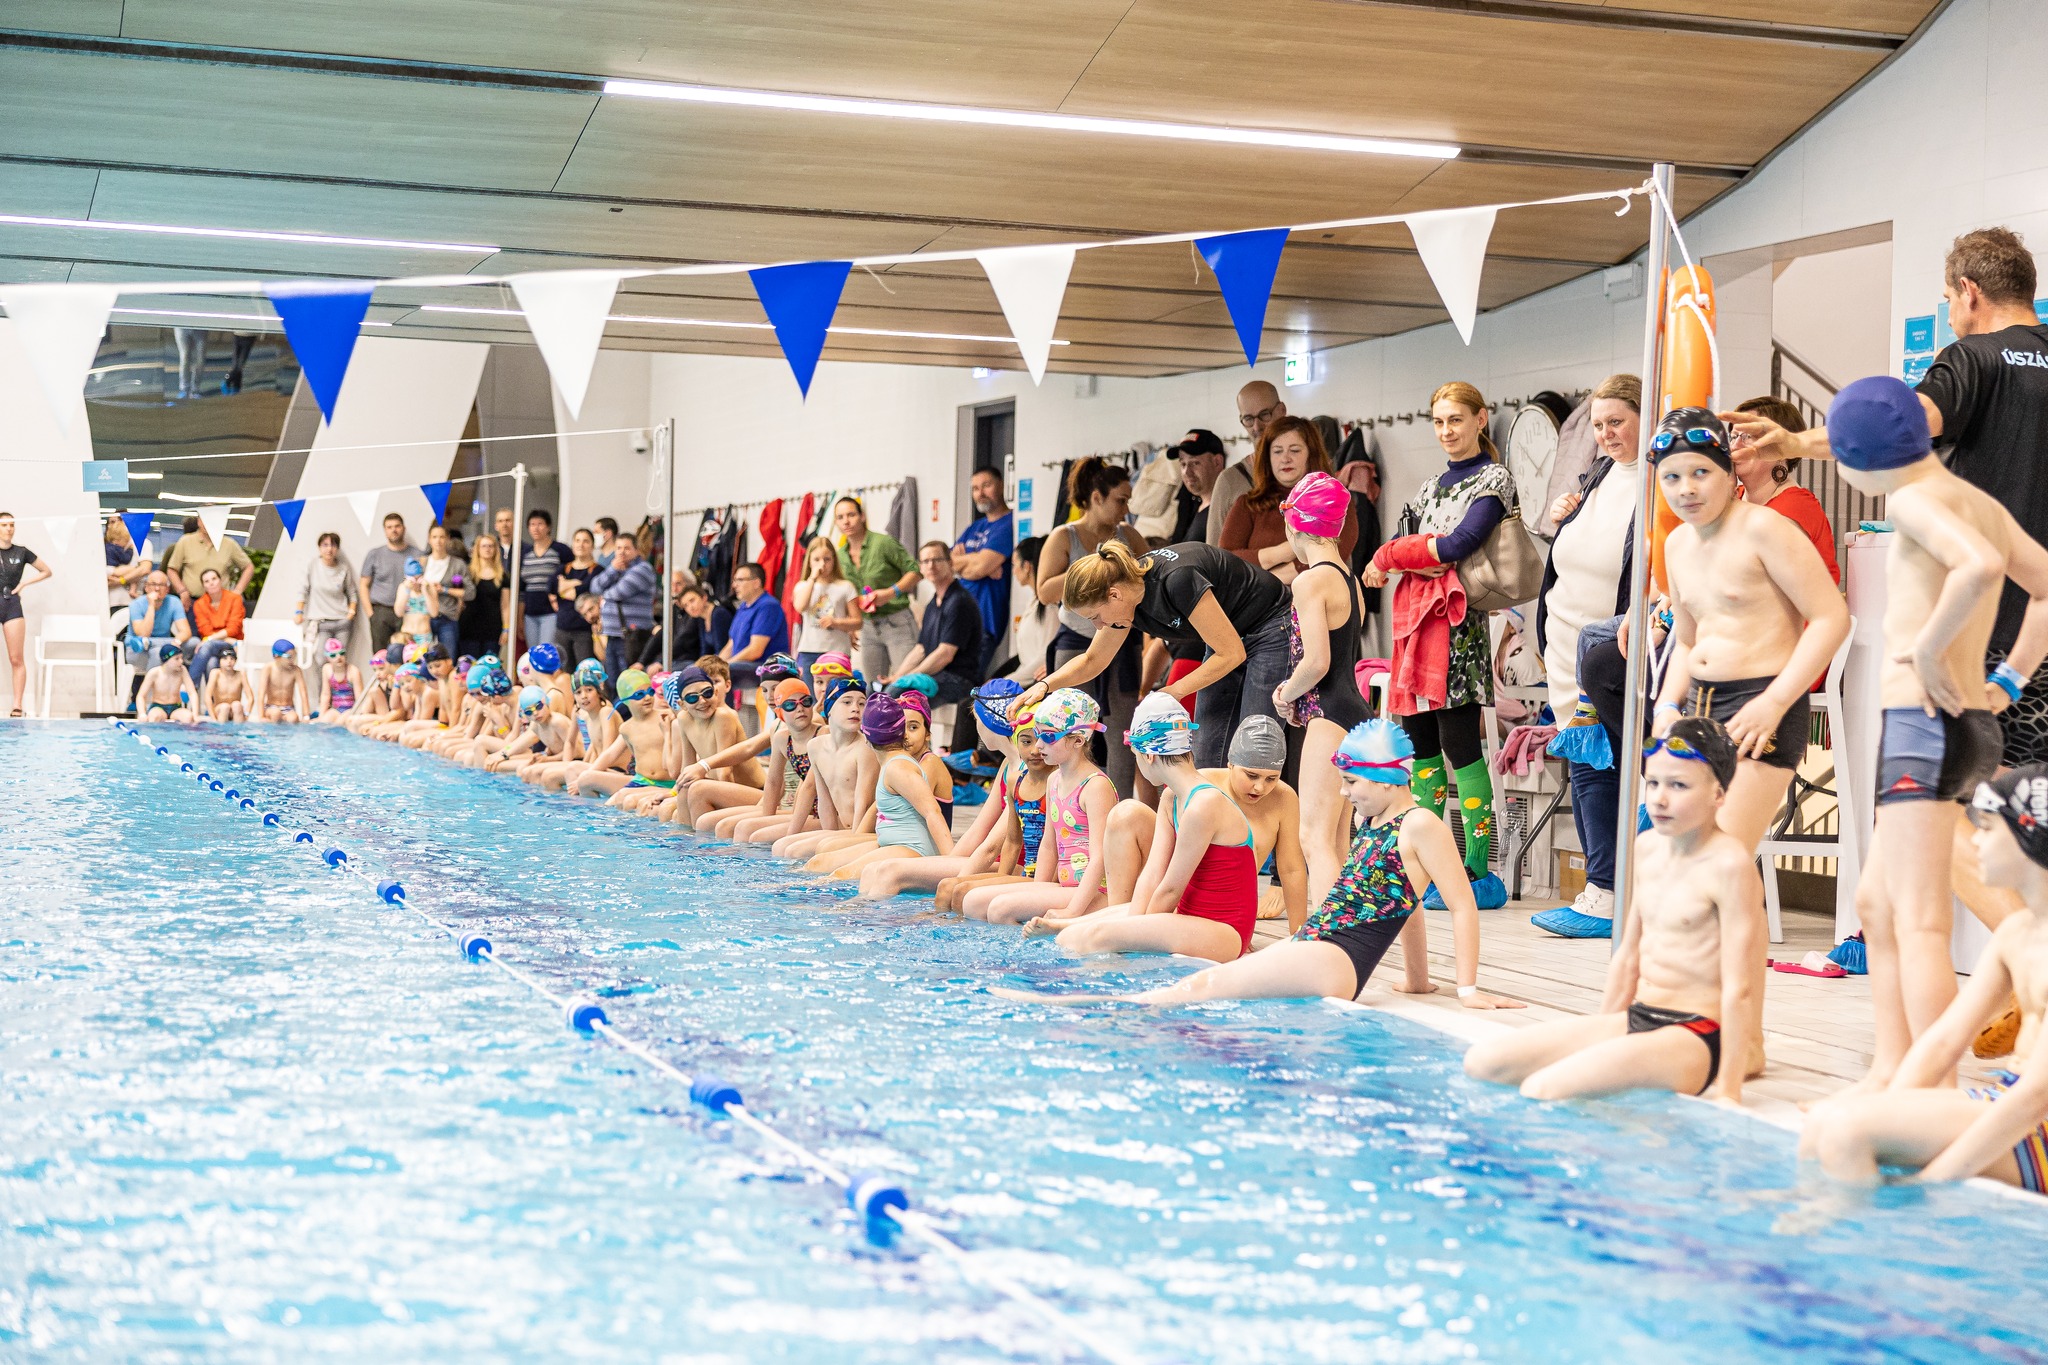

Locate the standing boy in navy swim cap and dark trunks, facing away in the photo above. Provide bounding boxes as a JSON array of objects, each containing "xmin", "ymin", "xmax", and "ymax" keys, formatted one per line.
[{"xmin": 1827, "ymin": 377, "xmax": 2048, "ymax": 1087}]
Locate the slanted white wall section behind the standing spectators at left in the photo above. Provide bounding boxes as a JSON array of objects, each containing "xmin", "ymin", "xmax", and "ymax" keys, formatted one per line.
[{"xmin": 250, "ymin": 336, "xmax": 487, "ymax": 663}]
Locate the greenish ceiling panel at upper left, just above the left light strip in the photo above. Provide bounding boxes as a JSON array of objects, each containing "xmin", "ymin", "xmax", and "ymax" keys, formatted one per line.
[{"xmin": 0, "ymin": 47, "xmax": 596, "ymax": 190}]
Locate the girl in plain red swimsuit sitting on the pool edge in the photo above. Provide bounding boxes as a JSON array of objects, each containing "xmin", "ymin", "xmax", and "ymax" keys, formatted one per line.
[{"xmin": 1024, "ymin": 692, "xmax": 1260, "ymax": 962}]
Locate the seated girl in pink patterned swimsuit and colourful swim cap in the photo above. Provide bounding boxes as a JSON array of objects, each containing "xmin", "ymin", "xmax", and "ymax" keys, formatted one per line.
[{"xmin": 961, "ymin": 688, "xmax": 1116, "ymax": 925}]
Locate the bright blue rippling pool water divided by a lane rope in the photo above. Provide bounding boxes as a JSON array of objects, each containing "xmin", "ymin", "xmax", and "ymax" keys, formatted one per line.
[{"xmin": 0, "ymin": 724, "xmax": 2048, "ymax": 1363}]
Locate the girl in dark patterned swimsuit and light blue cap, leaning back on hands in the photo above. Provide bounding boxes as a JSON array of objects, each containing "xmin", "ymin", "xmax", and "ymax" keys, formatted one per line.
[{"xmin": 995, "ymin": 720, "xmax": 1522, "ymax": 1009}]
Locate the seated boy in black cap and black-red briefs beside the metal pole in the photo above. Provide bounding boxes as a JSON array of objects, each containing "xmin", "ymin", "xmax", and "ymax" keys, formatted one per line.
[{"xmin": 1464, "ymin": 720, "xmax": 1769, "ymax": 1105}]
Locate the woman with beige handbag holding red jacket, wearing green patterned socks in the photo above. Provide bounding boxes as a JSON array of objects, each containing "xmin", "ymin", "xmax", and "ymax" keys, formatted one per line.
[{"xmin": 1364, "ymin": 383, "xmax": 1540, "ymax": 911}]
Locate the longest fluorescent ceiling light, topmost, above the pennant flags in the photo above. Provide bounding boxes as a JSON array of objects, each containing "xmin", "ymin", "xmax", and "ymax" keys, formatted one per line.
[{"xmin": 604, "ymin": 80, "xmax": 1458, "ymax": 162}]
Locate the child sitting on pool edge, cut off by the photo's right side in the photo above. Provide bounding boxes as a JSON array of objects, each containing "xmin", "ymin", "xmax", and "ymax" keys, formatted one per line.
[{"xmin": 1800, "ymin": 769, "xmax": 2048, "ymax": 1195}]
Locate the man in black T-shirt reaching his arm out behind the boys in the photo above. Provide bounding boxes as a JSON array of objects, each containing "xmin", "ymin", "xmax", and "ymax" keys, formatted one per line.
[{"xmin": 1720, "ymin": 227, "xmax": 2048, "ymax": 767}]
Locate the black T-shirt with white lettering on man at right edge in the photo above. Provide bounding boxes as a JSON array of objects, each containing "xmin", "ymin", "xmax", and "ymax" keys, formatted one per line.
[{"xmin": 1919, "ymin": 323, "xmax": 2048, "ymax": 653}]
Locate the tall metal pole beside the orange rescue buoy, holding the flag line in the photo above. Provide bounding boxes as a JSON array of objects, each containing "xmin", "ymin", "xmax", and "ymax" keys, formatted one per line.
[{"xmin": 1608, "ymin": 162, "xmax": 1675, "ymax": 954}]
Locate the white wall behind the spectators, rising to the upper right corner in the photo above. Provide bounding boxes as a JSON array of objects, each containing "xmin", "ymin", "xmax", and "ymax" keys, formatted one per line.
[{"xmin": 621, "ymin": 0, "xmax": 2048, "ymax": 536}]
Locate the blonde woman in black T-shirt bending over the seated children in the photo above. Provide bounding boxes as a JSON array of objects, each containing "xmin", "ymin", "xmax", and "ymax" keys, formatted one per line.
[{"xmin": 1018, "ymin": 540, "xmax": 1292, "ymax": 767}]
